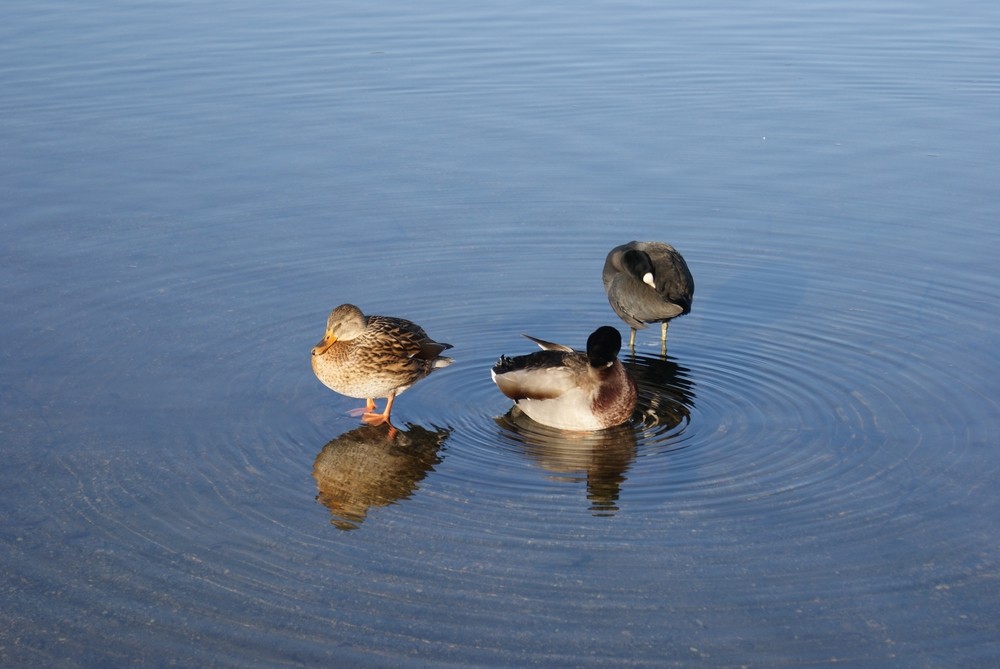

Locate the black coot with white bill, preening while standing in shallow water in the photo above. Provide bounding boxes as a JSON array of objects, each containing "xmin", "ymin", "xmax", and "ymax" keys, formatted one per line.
[{"xmin": 603, "ymin": 242, "xmax": 694, "ymax": 351}]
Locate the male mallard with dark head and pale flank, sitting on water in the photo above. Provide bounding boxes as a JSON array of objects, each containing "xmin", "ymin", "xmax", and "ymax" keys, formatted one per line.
[{"xmin": 491, "ymin": 325, "xmax": 636, "ymax": 430}]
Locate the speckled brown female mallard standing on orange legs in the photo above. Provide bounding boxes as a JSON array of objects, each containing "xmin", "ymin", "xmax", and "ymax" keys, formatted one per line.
[{"xmin": 312, "ymin": 304, "xmax": 452, "ymax": 425}]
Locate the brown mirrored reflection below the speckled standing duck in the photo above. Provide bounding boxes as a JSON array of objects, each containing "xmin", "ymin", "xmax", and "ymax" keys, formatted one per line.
[{"xmin": 313, "ymin": 424, "xmax": 451, "ymax": 530}]
